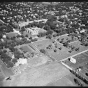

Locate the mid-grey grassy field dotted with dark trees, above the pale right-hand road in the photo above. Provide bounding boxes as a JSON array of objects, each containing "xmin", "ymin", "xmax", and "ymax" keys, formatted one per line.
[{"xmin": 33, "ymin": 37, "xmax": 88, "ymax": 61}]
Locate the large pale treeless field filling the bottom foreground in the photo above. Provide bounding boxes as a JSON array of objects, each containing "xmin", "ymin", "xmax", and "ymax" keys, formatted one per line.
[{"xmin": 5, "ymin": 63, "xmax": 70, "ymax": 86}]
